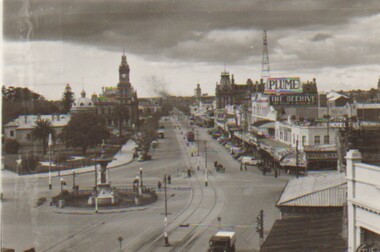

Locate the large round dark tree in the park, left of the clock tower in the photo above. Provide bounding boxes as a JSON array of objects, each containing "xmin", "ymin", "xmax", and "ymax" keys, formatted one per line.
[{"xmin": 62, "ymin": 113, "xmax": 110, "ymax": 154}]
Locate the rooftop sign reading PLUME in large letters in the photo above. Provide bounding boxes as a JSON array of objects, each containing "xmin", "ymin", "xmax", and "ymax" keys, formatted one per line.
[{"xmin": 264, "ymin": 77, "xmax": 303, "ymax": 95}]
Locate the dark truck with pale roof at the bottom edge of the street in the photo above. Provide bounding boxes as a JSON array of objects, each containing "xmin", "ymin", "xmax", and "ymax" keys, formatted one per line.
[{"xmin": 208, "ymin": 231, "xmax": 236, "ymax": 252}]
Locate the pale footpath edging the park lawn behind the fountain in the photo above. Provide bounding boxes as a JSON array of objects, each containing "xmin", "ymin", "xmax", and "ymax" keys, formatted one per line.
[{"xmin": 1, "ymin": 140, "xmax": 137, "ymax": 178}]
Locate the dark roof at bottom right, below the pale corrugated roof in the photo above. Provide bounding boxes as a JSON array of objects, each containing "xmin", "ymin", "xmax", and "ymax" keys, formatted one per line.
[{"xmin": 261, "ymin": 212, "xmax": 347, "ymax": 252}]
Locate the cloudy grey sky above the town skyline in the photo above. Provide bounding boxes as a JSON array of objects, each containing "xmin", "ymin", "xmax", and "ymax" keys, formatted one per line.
[{"xmin": 1, "ymin": 0, "xmax": 380, "ymax": 99}]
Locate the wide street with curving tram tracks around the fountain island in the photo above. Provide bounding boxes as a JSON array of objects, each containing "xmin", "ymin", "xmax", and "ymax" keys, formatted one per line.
[{"xmin": 1, "ymin": 115, "xmax": 288, "ymax": 251}]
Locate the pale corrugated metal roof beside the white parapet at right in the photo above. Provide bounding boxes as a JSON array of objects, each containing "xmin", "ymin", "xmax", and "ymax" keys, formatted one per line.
[{"xmin": 277, "ymin": 173, "xmax": 347, "ymax": 207}]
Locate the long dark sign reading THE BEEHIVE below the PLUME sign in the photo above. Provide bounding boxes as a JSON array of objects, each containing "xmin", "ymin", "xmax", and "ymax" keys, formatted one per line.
[{"xmin": 269, "ymin": 94, "xmax": 317, "ymax": 106}]
